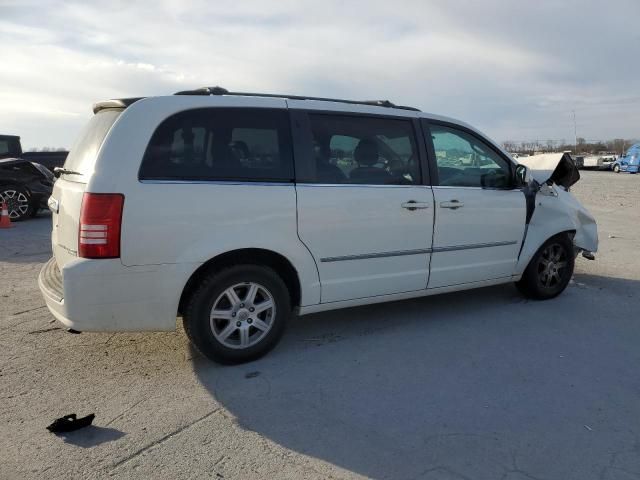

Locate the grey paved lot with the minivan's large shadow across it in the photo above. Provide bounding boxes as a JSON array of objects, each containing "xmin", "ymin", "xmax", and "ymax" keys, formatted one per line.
[{"xmin": 0, "ymin": 172, "xmax": 640, "ymax": 480}]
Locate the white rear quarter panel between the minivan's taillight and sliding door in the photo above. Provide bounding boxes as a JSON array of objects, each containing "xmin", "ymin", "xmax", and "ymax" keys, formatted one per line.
[{"xmin": 121, "ymin": 182, "xmax": 320, "ymax": 305}]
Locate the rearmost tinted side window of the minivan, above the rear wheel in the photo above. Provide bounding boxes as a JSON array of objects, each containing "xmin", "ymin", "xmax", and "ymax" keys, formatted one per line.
[{"xmin": 139, "ymin": 108, "xmax": 293, "ymax": 182}]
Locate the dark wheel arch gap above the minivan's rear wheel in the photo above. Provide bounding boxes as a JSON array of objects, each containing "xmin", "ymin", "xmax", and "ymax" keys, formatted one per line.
[{"xmin": 178, "ymin": 248, "xmax": 302, "ymax": 315}]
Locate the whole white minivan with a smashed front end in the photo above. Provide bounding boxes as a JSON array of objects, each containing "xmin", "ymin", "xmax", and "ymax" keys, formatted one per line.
[{"xmin": 39, "ymin": 87, "xmax": 597, "ymax": 363}]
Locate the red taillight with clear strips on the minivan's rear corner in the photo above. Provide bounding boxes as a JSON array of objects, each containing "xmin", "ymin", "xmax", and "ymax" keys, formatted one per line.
[{"xmin": 78, "ymin": 193, "xmax": 124, "ymax": 258}]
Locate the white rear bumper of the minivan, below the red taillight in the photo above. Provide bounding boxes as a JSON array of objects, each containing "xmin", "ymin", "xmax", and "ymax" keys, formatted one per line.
[{"xmin": 38, "ymin": 258, "xmax": 196, "ymax": 332}]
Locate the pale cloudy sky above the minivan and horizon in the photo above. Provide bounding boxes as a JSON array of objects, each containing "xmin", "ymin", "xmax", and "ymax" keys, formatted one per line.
[{"xmin": 0, "ymin": 0, "xmax": 640, "ymax": 149}]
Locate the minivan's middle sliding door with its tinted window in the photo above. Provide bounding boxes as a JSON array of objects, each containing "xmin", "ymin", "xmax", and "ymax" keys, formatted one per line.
[{"xmin": 292, "ymin": 112, "xmax": 433, "ymax": 303}]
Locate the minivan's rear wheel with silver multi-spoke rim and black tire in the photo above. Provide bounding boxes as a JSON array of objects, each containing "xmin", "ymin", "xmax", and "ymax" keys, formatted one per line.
[{"xmin": 183, "ymin": 265, "xmax": 291, "ymax": 364}]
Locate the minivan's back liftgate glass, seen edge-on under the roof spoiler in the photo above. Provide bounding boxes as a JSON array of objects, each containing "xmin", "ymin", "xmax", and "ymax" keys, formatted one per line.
[{"xmin": 64, "ymin": 109, "xmax": 122, "ymax": 180}]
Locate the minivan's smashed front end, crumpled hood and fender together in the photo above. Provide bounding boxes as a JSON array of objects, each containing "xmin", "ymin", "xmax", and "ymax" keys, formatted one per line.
[{"xmin": 518, "ymin": 153, "xmax": 598, "ymax": 269}]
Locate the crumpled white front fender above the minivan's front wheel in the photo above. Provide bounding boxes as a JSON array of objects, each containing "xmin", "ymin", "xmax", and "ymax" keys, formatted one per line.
[{"xmin": 514, "ymin": 185, "xmax": 598, "ymax": 275}]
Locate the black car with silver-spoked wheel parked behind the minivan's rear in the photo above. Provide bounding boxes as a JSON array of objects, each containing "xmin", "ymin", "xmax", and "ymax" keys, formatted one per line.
[{"xmin": 0, "ymin": 158, "xmax": 54, "ymax": 221}]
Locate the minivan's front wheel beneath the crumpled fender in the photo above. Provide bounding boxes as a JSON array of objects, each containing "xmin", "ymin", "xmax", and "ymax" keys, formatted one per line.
[{"xmin": 516, "ymin": 234, "xmax": 575, "ymax": 300}]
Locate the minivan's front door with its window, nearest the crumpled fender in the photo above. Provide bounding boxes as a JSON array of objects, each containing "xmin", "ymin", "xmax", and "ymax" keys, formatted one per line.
[{"xmin": 427, "ymin": 123, "xmax": 526, "ymax": 288}]
